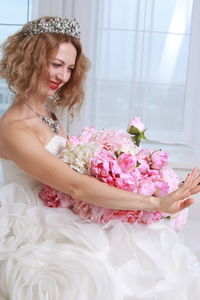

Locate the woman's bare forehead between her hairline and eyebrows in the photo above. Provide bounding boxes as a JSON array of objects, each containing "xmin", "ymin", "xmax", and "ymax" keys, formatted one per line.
[{"xmin": 52, "ymin": 42, "xmax": 77, "ymax": 64}]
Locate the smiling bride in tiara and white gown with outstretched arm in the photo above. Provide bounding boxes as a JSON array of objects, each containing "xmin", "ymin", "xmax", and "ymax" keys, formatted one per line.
[{"xmin": 0, "ymin": 17, "xmax": 200, "ymax": 300}]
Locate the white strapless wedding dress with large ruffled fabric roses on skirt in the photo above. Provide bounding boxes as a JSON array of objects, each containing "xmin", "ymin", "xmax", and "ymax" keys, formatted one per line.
[{"xmin": 0, "ymin": 136, "xmax": 200, "ymax": 300}]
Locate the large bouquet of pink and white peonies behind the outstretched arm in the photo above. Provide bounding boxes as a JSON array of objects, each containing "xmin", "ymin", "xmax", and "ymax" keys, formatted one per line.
[{"xmin": 40, "ymin": 118, "xmax": 188, "ymax": 231}]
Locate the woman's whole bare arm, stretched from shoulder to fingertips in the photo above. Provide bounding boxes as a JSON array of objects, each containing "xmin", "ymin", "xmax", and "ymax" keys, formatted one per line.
[{"xmin": 0, "ymin": 127, "xmax": 200, "ymax": 212}]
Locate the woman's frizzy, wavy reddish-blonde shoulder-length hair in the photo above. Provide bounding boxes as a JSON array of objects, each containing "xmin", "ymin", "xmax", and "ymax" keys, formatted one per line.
[{"xmin": 0, "ymin": 17, "xmax": 89, "ymax": 115}]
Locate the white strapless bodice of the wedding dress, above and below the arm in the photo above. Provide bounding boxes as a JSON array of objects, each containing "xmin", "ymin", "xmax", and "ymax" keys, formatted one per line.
[{"xmin": 1, "ymin": 135, "xmax": 67, "ymax": 186}]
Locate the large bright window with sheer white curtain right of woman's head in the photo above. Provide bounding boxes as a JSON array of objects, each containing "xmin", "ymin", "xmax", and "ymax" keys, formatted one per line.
[{"xmin": 33, "ymin": 0, "xmax": 200, "ymax": 169}]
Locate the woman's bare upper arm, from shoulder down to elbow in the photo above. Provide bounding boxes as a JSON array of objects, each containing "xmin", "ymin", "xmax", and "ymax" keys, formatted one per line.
[{"xmin": 0, "ymin": 107, "xmax": 82, "ymax": 194}]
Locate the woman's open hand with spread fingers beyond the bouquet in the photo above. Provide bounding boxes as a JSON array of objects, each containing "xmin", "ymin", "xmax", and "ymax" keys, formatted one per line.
[{"xmin": 158, "ymin": 168, "xmax": 200, "ymax": 213}]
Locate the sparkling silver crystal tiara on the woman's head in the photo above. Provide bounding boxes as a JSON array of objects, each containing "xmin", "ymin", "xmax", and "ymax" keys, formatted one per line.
[{"xmin": 23, "ymin": 17, "xmax": 80, "ymax": 40}]
